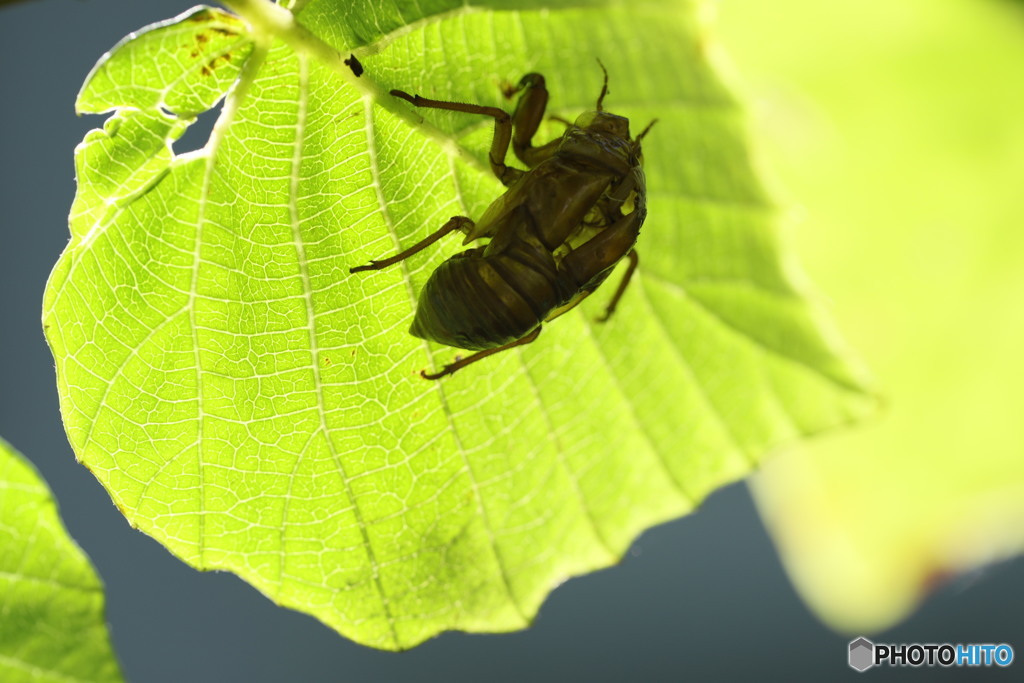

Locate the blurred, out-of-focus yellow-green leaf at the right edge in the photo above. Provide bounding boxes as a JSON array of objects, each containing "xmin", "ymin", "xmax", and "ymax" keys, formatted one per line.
[{"xmin": 723, "ymin": 0, "xmax": 1024, "ymax": 632}]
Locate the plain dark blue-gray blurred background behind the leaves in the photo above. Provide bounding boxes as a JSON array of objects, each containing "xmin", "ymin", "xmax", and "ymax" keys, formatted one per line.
[{"xmin": 0, "ymin": 0, "xmax": 1024, "ymax": 683}]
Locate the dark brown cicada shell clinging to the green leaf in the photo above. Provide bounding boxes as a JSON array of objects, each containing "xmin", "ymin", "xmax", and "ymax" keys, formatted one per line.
[{"xmin": 350, "ymin": 65, "xmax": 654, "ymax": 380}]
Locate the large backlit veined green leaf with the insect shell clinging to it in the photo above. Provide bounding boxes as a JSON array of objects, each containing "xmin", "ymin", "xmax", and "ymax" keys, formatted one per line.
[{"xmin": 45, "ymin": 0, "xmax": 871, "ymax": 648}]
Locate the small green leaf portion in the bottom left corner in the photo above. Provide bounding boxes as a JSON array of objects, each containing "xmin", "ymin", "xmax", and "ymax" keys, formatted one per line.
[{"xmin": 0, "ymin": 439, "xmax": 121, "ymax": 683}]
